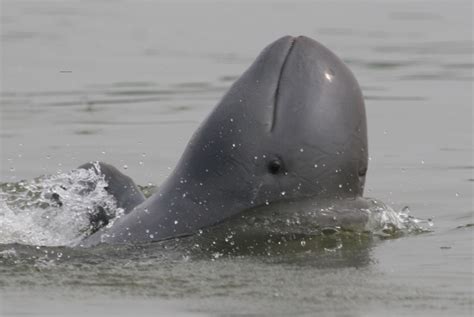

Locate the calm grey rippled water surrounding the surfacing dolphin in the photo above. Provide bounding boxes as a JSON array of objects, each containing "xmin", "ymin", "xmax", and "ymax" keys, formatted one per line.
[{"xmin": 0, "ymin": 0, "xmax": 474, "ymax": 316}]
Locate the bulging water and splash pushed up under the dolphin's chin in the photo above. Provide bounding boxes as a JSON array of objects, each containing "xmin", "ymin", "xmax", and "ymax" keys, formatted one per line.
[{"xmin": 224, "ymin": 197, "xmax": 433, "ymax": 238}]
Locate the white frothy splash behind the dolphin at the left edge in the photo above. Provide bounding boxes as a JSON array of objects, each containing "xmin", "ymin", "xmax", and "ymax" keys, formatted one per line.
[{"xmin": 0, "ymin": 163, "xmax": 123, "ymax": 246}]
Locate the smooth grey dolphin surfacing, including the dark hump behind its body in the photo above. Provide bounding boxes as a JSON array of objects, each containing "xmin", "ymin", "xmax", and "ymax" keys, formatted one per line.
[{"xmin": 82, "ymin": 36, "xmax": 368, "ymax": 246}]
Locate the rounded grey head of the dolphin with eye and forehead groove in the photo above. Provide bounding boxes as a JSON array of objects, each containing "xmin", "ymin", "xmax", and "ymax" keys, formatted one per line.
[{"xmin": 172, "ymin": 36, "xmax": 367, "ymax": 209}]
